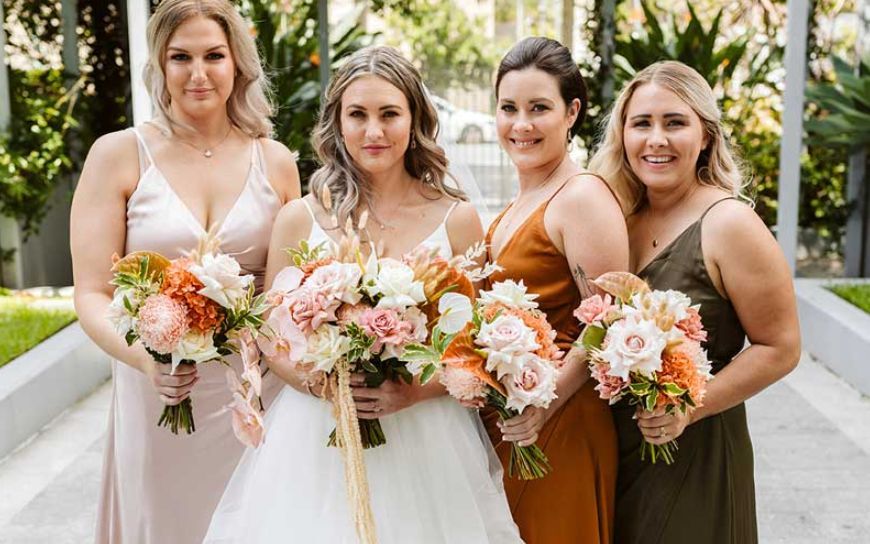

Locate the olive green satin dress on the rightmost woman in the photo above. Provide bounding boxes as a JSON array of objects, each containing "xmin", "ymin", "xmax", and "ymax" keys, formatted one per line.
[{"xmin": 613, "ymin": 199, "xmax": 758, "ymax": 544}]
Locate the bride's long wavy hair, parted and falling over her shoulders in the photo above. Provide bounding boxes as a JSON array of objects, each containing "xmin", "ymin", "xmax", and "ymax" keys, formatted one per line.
[{"xmin": 311, "ymin": 46, "xmax": 467, "ymax": 225}]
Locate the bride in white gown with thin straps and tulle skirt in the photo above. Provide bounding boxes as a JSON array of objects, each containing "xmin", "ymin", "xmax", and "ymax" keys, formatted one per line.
[{"xmin": 205, "ymin": 47, "xmax": 521, "ymax": 544}]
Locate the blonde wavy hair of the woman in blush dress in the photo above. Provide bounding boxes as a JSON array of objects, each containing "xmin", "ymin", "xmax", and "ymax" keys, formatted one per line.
[{"xmin": 144, "ymin": 0, "xmax": 274, "ymax": 138}]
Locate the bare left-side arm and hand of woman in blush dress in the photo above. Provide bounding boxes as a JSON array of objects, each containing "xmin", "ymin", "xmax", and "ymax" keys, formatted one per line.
[{"xmin": 70, "ymin": 132, "xmax": 196, "ymax": 404}]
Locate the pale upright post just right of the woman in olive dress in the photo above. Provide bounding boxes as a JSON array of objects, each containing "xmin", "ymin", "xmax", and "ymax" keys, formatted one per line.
[{"xmin": 776, "ymin": 0, "xmax": 809, "ymax": 274}]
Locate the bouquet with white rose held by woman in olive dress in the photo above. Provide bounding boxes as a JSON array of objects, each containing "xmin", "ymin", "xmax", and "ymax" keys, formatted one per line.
[{"xmin": 574, "ymin": 272, "xmax": 712, "ymax": 464}]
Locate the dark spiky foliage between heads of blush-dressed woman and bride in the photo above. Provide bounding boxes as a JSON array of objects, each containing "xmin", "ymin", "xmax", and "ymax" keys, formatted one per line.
[{"xmin": 239, "ymin": 0, "xmax": 372, "ymax": 181}]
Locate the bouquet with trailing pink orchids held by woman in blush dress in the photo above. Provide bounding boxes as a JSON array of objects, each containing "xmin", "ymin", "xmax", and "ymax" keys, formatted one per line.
[{"xmin": 107, "ymin": 235, "xmax": 267, "ymax": 445}]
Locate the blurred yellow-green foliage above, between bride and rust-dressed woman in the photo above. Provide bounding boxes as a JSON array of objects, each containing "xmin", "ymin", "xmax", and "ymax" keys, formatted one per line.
[{"xmin": 380, "ymin": 0, "xmax": 497, "ymax": 94}]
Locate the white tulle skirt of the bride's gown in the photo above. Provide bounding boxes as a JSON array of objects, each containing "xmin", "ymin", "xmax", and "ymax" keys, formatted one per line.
[{"xmin": 204, "ymin": 386, "xmax": 522, "ymax": 544}]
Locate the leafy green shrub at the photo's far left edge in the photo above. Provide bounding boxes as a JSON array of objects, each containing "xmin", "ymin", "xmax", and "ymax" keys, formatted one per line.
[{"xmin": 0, "ymin": 70, "xmax": 80, "ymax": 238}]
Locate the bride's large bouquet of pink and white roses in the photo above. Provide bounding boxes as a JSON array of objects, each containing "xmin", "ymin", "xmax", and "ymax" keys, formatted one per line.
[{"xmin": 259, "ymin": 233, "xmax": 498, "ymax": 449}]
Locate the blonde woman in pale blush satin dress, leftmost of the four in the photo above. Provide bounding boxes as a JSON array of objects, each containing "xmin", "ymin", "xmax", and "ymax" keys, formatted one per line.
[{"xmin": 71, "ymin": 0, "xmax": 299, "ymax": 544}]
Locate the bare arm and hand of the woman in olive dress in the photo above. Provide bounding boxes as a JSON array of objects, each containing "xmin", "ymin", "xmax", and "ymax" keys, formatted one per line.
[{"xmin": 639, "ymin": 201, "xmax": 800, "ymax": 443}]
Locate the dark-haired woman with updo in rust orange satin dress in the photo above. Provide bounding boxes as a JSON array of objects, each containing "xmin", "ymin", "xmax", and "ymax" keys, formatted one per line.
[{"xmin": 485, "ymin": 38, "xmax": 628, "ymax": 544}]
